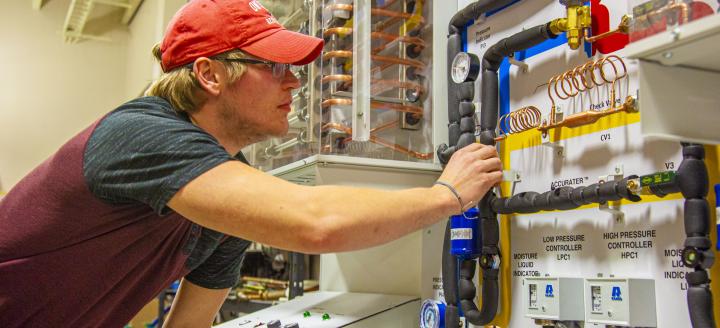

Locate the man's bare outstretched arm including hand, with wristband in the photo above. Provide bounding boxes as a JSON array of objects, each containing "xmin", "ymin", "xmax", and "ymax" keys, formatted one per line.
[{"xmin": 168, "ymin": 144, "xmax": 502, "ymax": 253}]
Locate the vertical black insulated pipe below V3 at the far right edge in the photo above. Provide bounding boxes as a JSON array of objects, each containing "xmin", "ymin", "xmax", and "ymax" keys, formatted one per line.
[{"xmin": 676, "ymin": 143, "xmax": 716, "ymax": 328}]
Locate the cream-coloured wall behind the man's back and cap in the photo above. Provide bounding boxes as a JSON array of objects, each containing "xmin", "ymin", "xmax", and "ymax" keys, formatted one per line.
[{"xmin": 0, "ymin": 0, "xmax": 185, "ymax": 197}]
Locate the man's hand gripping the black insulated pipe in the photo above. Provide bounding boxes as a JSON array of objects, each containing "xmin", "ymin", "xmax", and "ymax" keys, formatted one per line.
[{"xmin": 438, "ymin": 143, "xmax": 502, "ymax": 209}]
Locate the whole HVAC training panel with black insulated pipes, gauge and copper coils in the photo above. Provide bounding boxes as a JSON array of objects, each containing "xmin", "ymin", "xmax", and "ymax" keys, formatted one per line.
[{"xmin": 438, "ymin": 0, "xmax": 717, "ymax": 327}]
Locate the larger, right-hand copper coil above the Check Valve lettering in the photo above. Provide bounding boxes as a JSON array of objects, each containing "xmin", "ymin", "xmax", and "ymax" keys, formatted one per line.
[{"xmin": 547, "ymin": 55, "xmax": 628, "ymax": 124}]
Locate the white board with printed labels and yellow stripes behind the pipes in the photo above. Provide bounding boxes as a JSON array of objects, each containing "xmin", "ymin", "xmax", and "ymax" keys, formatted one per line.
[{"xmin": 466, "ymin": 1, "xmax": 717, "ymax": 327}]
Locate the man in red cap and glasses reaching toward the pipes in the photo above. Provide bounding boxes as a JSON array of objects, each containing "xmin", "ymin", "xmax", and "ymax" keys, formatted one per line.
[{"xmin": 0, "ymin": 0, "xmax": 501, "ymax": 327}]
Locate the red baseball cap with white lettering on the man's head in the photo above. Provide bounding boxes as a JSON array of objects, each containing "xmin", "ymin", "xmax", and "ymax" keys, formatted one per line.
[{"xmin": 160, "ymin": 0, "xmax": 323, "ymax": 72}]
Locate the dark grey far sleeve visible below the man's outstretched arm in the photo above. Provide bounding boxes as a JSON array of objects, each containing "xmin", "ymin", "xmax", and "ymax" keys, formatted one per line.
[{"xmin": 185, "ymin": 236, "xmax": 250, "ymax": 289}]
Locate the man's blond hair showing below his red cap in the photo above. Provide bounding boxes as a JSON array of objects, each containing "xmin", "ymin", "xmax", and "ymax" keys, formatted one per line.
[{"xmin": 145, "ymin": 44, "xmax": 246, "ymax": 113}]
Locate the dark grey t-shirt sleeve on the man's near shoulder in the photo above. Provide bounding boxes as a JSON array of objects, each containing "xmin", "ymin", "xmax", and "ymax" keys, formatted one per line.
[{"xmin": 83, "ymin": 98, "xmax": 235, "ymax": 214}]
